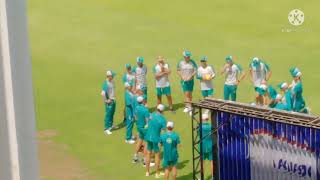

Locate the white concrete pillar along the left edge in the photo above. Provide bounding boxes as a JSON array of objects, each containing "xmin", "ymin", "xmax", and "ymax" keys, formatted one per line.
[{"xmin": 0, "ymin": 0, "xmax": 39, "ymax": 180}]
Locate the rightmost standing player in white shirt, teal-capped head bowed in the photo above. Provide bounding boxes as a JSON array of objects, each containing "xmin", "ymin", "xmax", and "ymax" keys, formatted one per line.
[{"xmin": 249, "ymin": 57, "xmax": 271, "ymax": 106}]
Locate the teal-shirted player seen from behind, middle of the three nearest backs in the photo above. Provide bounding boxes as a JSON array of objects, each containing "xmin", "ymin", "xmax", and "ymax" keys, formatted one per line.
[{"xmin": 145, "ymin": 104, "xmax": 167, "ymax": 178}]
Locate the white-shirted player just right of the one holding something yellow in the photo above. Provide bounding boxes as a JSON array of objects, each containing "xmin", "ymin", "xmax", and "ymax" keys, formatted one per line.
[{"xmin": 221, "ymin": 56, "xmax": 246, "ymax": 101}]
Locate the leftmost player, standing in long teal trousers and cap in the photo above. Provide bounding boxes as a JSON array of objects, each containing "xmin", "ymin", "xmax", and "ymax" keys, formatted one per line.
[{"xmin": 101, "ymin": 71, "xmax": 116, "ymax": 135}]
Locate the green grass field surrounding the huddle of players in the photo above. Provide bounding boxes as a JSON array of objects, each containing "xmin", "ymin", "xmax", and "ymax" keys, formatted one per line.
[{"xmin": 28, "ymin": 0, "xmax": 320, "ymax": 180}]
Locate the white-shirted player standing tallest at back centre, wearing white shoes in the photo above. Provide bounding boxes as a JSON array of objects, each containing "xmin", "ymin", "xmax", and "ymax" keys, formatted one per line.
[{"xmin": 177, "ymin": 51, "xmax": 197, "ymax": 115}]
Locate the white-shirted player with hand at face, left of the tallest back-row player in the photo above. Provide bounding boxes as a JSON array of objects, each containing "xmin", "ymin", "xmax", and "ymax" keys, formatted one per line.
[{"xmin": 153, "ymin": 56, "xmax": 173, "ymax": 111}]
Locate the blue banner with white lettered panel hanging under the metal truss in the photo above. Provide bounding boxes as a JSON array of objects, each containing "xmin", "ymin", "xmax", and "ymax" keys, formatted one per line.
[{"xmin": 216, "ymin": 112, "xmax": 320, "ymax": 180}]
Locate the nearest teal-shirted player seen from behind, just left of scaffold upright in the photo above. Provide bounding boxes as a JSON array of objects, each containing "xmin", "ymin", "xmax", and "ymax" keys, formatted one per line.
[{"xmin": 160, "ymin": 121, "xmax": 180, "ymax": 180}]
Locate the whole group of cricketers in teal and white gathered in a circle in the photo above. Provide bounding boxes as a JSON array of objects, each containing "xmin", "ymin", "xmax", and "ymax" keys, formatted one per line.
[{"xmin": 101, "ymin": 51, "xmax": 308, "ymax": 179}]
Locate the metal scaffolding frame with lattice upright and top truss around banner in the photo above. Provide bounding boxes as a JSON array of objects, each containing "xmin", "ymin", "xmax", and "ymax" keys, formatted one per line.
[{"xmin": 191, "ymin": 98, "xmax": 320, "ymax": 180}]
